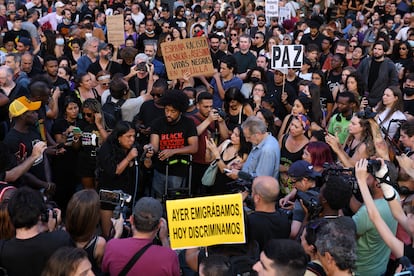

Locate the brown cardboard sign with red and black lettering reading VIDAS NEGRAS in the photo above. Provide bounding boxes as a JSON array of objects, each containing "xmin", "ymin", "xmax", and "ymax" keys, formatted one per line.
[{"xmin": 161, "ymin": 37, "xmax": 214, "ymax": 80}]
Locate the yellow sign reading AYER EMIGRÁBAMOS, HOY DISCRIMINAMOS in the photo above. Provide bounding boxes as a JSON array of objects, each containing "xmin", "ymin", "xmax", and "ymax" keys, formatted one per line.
[{"xmin": 166, "ymin": 194, "xmax": 246, "ymax": 249}]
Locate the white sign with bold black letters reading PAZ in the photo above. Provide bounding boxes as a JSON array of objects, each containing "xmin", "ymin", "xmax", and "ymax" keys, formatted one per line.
[{"xmin": 271, "ymin": 45, "xmax": 304, "ymax": 69}]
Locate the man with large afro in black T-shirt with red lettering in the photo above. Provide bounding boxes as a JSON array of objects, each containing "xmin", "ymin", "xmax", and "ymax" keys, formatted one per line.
[{"xmin": 149, "ymin": 90, "xmax": 198, "ymax": 198}]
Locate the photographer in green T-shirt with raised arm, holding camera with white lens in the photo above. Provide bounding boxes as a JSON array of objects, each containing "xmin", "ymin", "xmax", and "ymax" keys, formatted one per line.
[{"xmin": 352, "ymin": 159, "xmax": 400, "ymax": 276}]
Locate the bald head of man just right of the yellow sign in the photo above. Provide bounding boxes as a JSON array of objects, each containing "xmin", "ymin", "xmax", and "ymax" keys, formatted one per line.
[{"xmin": 252, "ymin": 176, "xmax": 279, "ymax": 204}]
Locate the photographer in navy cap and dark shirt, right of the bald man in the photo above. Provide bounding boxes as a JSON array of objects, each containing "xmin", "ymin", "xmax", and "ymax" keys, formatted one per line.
[{"xmin": 283, "ymin": 160, "xmax": 321, "ymax": 239}]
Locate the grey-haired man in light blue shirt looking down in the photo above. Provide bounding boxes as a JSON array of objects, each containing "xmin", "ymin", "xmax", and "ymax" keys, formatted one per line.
[{"xmin": 228, "ymin": 116, "xmax": 280, "ymax": 179}]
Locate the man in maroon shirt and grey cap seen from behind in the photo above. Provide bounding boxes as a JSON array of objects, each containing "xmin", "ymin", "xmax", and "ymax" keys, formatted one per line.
[{"xmin": 102, "ymin": 197, "xmax": 180, "ymax": 276}]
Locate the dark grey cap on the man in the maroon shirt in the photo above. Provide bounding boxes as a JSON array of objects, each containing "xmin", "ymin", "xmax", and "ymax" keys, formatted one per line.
[{"xmin": 134, "ymin": 197, "xmax": 162, "ymax": 226}]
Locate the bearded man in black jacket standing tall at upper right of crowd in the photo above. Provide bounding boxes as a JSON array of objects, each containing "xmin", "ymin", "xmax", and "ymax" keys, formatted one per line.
[{"xmin": 357, "ymin": 41, "xmax": 398, "ymax": 107}]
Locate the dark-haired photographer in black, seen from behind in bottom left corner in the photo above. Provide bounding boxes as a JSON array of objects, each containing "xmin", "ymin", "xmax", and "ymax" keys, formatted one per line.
[{"xmin": 0, "ymin": 187, "xmax": 73, "ymax": 275}]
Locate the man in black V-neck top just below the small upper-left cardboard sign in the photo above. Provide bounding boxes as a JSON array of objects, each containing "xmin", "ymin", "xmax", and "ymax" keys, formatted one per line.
[{"xmin": 88, "ymin": 42, "xmax": 122, "ymax": 77}]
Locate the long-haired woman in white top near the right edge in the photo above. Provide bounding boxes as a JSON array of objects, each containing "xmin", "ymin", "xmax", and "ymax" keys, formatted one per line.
[{"xmin": 375, "ymin": 86, "xmax": 407, "ymax": 139}]
